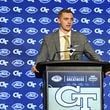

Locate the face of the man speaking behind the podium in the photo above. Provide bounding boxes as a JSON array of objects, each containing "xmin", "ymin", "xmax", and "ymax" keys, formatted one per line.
[{"xmin": 58, "ymin": 13, "xmax": 73, "ymax": 32}]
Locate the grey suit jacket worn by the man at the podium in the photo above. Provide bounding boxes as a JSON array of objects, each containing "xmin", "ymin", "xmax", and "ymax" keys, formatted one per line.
[{"xmin": 36, "ymin": 31, "xmax": 102, "ymax": 64}]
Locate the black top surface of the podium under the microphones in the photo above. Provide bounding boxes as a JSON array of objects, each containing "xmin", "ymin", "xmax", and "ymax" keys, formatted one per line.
[{"xmin": 36, "ymin": 60, "xmax": 110, "ymax": 73}]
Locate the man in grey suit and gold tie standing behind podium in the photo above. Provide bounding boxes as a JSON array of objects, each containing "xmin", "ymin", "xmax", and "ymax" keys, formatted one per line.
[{"xmin": 32, "ymin": 9, "xmax": 102, "ymax": 72}]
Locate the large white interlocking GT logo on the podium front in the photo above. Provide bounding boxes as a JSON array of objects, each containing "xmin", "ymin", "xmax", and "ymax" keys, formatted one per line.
[{"xmin": 55, "ymin": 86, "xmax": 97, "ymax": 110}]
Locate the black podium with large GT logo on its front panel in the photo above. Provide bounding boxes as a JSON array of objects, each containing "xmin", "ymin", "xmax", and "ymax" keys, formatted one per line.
[{"xmin": 38, "ymin": 61, "xmax": 110, "ymax": 110}]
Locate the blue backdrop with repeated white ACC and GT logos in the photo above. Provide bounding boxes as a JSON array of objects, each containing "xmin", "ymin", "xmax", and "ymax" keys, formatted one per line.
[{"xmin": 0, "ymin": 0, "xmax": 110, "ymax": 110}]
